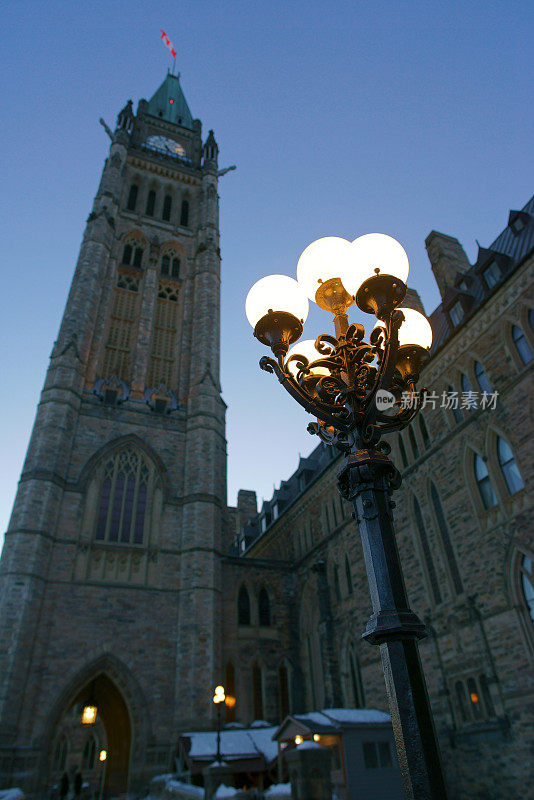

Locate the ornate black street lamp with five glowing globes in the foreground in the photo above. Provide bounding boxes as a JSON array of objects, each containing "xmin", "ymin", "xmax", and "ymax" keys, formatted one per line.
[{"xmin": 246, "ymin": 233, "xmax": 446, "ymax": 800}]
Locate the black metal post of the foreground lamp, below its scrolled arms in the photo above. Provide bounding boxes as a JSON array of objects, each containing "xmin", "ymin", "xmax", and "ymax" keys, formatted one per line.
[{"xmin": 338, "ymin": 445, "xmax": 447, "ymax": 800}]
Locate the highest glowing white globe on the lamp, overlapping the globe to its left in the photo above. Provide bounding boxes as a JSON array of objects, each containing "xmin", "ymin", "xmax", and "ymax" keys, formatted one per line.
[{"xmin": 341, "ymin": 233, "xmax": 410, "ymax": 294}]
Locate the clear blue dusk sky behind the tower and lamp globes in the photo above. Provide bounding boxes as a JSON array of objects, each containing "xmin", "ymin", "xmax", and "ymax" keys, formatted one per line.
[{"xmin": 0, "ymin": 0, "xmax": 534, "ymax": 538}]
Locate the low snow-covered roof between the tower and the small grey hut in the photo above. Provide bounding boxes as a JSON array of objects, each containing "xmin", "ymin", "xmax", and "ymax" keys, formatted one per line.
[{"xmin": 181, "ymin": 725, "xmax": 278, "ymax": 764}]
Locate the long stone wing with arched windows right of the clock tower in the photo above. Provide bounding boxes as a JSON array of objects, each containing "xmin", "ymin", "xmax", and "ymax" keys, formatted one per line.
[{"xmin": 229, "ymin": 198, "xmax": 534, "ymax": 800}]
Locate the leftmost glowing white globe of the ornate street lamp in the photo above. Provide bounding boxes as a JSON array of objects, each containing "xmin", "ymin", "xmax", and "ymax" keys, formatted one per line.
[{"xmin": 245, "ymin": 275, "xmax": 309, "ymax": 328}]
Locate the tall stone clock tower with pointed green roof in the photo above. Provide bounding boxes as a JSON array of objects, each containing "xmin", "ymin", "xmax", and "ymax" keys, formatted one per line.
[{"xmin": 0, "ymin": 74, "xmax": 226, "ymax": 797}]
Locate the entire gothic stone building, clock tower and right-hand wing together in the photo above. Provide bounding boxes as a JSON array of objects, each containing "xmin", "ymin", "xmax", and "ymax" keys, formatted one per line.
[{"xmin": 0, "ymin": 65, "xmax": 534, "ymax": 800}]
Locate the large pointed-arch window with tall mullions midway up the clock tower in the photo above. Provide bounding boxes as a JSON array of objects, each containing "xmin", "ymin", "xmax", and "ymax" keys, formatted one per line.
[{"xmin": 95, "ymin": 449, "xmax": 150, "ymax": 544}]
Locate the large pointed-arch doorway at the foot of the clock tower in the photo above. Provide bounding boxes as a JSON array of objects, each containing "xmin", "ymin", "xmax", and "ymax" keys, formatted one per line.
[{"xmin": 50, "ymin": 672, "xmax": 132, "ymax": 799}]
